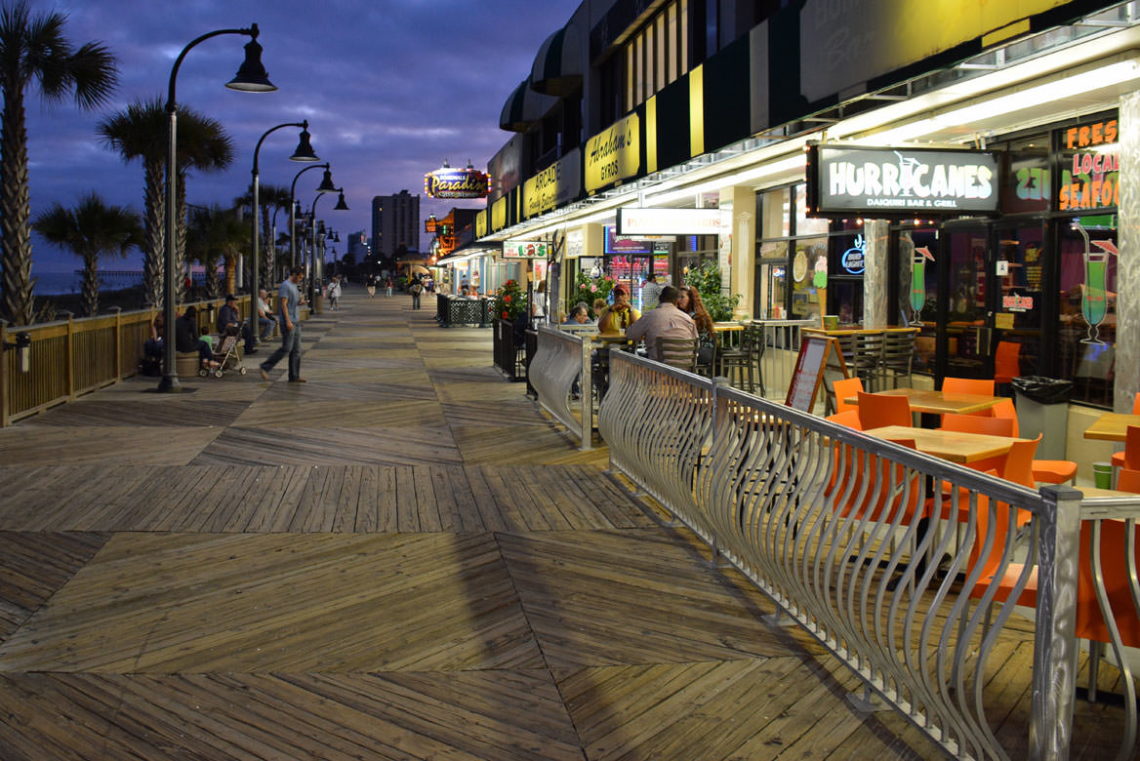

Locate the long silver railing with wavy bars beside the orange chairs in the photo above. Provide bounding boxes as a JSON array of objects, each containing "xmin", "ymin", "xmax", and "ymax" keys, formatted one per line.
[{"xmin": 599, "ymin": 352, "xmax": 1089, "ymax": 761}]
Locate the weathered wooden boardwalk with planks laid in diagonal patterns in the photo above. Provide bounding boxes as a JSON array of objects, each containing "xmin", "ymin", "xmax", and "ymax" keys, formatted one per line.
[{"xmin": 0, "ymin": 289, "xmax": 966, "ymax": 761}]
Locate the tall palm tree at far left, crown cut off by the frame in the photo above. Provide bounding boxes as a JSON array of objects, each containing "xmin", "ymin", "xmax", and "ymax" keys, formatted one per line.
[{"xmin": 0, "ymin": 0, "xmax": 119, "ymax": 325}]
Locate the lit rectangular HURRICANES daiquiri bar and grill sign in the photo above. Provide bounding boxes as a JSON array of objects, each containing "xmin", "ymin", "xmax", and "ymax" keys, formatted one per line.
[{"xmin": 807, "ymin": 145, "xmax": 999, "ymax": 216}]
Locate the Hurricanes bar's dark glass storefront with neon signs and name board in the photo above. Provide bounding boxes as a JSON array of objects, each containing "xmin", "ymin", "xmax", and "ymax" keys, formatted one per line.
[{"xmin": 754, "ymin": 111, "xmax": 1122, "ymax": 407}]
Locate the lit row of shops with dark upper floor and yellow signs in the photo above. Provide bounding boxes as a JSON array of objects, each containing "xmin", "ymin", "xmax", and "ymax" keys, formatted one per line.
[{"xmin": 477, "ymin": 0, "xmax": 1140, "ymax": 469}]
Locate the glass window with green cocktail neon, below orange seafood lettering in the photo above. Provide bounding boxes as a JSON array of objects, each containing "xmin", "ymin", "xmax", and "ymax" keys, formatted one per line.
[{"xmin": 1058, "ymin": 214, "xmax": 1117, "ymax": 407}]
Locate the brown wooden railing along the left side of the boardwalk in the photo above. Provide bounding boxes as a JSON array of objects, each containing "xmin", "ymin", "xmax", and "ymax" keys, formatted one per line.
[{"xmin": 0, "ymin": 296, "xmax": 261, "ymax": 426}]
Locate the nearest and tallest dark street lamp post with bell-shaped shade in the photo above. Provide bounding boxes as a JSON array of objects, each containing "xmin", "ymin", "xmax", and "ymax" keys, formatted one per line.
[{"xmin": 158, "ymin": 24, "xmax": 277, "ymax": 392}]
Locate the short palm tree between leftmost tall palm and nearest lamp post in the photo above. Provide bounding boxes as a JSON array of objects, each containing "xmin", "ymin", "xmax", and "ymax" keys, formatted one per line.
[{"xmin": 34, "ymin": 191, "xmax": 143, "ymax": 317}]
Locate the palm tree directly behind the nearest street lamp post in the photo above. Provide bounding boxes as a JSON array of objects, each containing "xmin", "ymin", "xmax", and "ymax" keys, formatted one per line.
[{"xmin": 98, "ymin": 98, "xmax": 233, "ymax": 304}]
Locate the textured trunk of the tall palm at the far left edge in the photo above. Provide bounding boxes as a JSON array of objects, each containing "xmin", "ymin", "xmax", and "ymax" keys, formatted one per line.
[{"xmin": 0, "ymin": 82, "xmax": 35, "ymax": 325}]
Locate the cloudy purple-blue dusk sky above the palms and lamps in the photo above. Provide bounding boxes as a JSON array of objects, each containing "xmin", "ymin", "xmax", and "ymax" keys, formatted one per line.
[{"xmin": 26, "ymin": 0, "xmax": 580, "ymax": 277}]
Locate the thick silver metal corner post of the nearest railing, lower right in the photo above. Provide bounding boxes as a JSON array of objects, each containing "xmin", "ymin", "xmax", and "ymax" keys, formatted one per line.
[{"xmin": 1029, "ymin": 486, "xmax": 1082, "ymax": 761}]
